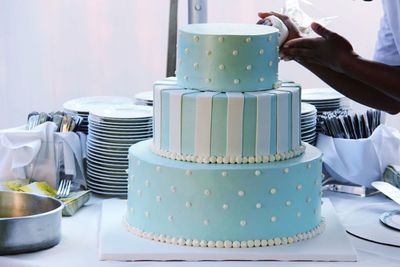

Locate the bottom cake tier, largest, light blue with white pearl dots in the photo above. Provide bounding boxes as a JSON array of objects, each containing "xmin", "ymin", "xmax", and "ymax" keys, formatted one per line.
[{"xmin": 126, "ymin": 140, "xmax": 324, "ymax": 248}]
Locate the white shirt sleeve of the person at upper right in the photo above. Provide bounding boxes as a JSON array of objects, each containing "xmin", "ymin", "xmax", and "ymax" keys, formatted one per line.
[{"xmin": 374, "ymin": 1, "xmax": 400, "ymax": 66}]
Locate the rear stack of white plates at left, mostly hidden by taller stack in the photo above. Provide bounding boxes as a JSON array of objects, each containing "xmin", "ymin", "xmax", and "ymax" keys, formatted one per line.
[{"xmin": 63, "ymin": 96, "xmax": 133, "ymax": 134}]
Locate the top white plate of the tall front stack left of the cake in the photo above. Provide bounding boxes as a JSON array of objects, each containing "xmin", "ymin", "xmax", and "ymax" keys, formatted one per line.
[{"xmin": 89, "ymin": 104, "xmax": 153, "ymax": 120}]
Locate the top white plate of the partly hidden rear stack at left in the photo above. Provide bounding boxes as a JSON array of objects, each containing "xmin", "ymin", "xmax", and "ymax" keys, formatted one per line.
[{"xmin": 63, "ymin": 96, "xmax": 133, "ymax": 114}]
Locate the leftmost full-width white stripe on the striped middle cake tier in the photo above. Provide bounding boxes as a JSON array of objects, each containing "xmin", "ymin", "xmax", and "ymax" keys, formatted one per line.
[{"xmin": 168, "ymin": 90, "xmax": 186, "ymax": 153}]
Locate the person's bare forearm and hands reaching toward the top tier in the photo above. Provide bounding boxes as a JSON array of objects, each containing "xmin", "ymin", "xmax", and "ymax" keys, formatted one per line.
[{"xmin": 259, "ymin": 13, "xmax": 400, "ymax": 114}]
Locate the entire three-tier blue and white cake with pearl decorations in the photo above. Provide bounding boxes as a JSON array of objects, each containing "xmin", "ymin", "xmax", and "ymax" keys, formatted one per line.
[{"xmin": 126, "ymin": 24, "xmax": 324, "ymax": 248}]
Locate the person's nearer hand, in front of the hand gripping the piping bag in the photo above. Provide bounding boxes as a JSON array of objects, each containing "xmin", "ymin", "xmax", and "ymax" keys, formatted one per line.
[{"xmin": 280, "ymin": 22, "xmax": 357, "ymax": 72}]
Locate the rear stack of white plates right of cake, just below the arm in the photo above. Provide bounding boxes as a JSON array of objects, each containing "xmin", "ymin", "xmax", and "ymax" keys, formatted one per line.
[{"xmin": 301, "ymin": 88, "xmax": 347, "ymax": 115}]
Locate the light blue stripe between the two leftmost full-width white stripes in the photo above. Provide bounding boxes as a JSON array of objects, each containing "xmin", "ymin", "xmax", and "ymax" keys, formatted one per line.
[{"xmin": 181, "ymin": 93, "xmax": 199, "ymax": 155}]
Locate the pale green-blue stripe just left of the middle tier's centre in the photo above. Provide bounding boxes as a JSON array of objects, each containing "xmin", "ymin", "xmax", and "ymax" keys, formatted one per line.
[{"xmin": 211, "ymin": 93, "xmax": 228, "ymax": 156}]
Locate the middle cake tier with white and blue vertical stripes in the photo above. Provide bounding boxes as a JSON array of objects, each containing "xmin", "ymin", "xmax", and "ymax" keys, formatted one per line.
[{"xmin": 153, "ymin": 82, "xmax": 304, "ymax": 163}]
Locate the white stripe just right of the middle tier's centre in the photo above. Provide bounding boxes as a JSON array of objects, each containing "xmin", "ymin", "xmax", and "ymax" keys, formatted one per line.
[{"xmin": 226, "ymin": 93, "xmax": 244, "ymax": 156}]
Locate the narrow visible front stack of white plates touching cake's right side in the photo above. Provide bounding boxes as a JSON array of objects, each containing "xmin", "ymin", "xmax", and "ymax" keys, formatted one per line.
[{"xmin": 301, "ymin": 103, "xmax": 317, "ymax": 145}]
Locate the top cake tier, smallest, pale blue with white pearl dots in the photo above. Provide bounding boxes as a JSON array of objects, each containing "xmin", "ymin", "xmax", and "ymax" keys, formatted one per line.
[{"xmin": 176, "ymin": 24, "xmax": 279, "ymax": 92}]
